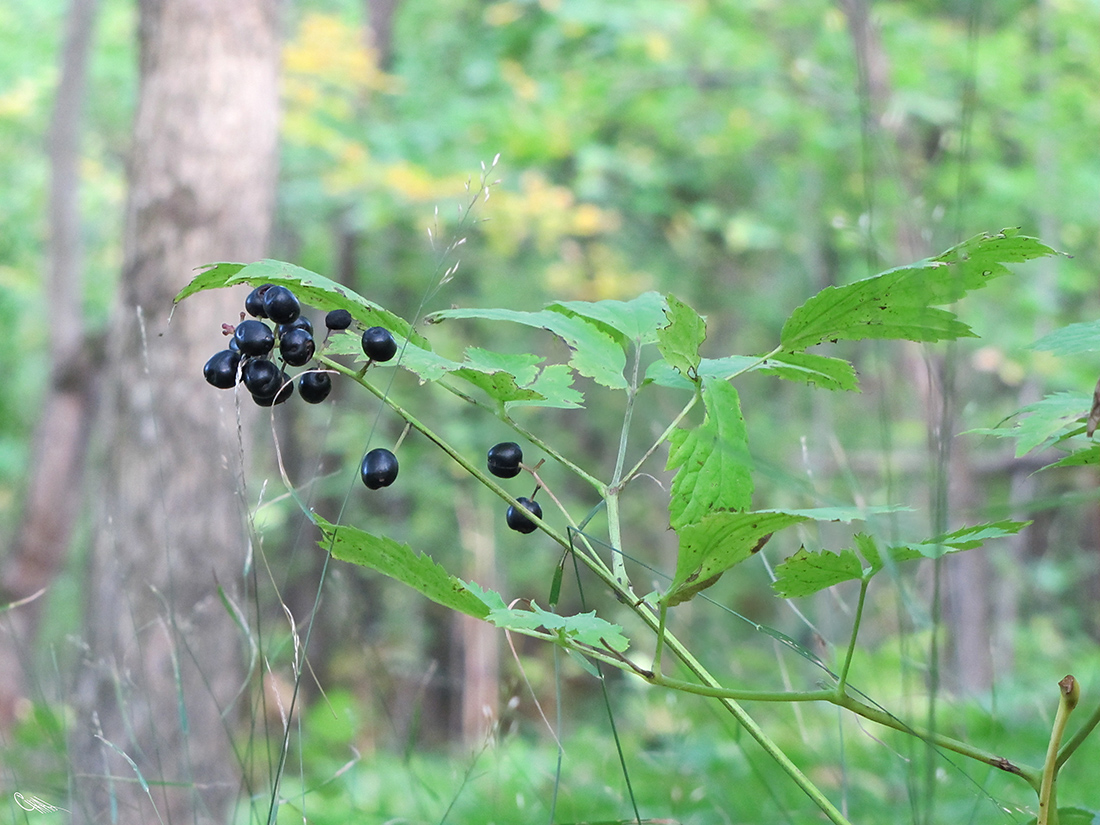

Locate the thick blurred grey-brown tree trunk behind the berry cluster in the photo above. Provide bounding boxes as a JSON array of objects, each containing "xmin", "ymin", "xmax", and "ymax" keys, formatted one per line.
[{"xmin": 70, "ymin": 0, "xmax": 278, "ymax": 825}]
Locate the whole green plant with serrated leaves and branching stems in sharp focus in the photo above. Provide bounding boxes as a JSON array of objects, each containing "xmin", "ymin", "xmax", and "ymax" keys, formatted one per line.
[{"xmin": 176, "ymin": 230, "xmax": 1100, "ymax": 825}]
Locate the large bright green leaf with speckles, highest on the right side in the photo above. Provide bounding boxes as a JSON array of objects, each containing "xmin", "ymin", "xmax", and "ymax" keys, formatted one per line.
[{"xmin": 780, "ymin": 230, "xmax": 1056, "ymax": 352}]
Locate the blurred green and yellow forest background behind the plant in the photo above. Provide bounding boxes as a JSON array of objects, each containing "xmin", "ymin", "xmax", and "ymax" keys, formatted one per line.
[{"xmin": 0, "ymin": 0, "xmax": 1100, "ymax": 823}]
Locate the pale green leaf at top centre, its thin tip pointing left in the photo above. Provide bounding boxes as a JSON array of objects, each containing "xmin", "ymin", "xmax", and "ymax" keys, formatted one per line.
[{"xmin": 427, "ymin": 309, "xmax": 628, "ymax": 389}]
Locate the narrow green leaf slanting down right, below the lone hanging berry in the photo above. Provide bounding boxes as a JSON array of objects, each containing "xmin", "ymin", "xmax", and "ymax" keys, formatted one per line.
[{"xmin": 315, "ymin": 516, "xmax": 492, "ymax": 619}]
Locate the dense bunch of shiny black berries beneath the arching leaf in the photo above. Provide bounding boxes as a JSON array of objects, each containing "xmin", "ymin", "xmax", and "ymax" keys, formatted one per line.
[{"xmin": 202, "ymin": 284, "xmax": 351, "ymax": 407}]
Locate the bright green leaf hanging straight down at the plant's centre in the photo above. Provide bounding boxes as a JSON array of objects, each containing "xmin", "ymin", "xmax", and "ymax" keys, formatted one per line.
[{"xmin": 667, "ymin": 378, "xmax": 752, "ymax": 531}]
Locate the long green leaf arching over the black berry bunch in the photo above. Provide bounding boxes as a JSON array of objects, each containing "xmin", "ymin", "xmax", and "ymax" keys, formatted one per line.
[{"xmin": 174, "ymin": 260, "xmax": 431, "ymax": 350}]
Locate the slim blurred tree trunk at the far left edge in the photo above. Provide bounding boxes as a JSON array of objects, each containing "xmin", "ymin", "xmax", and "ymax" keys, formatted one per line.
[{"xmin": 0, "ymin": 0, "xmax": 97, "ymax": 730}]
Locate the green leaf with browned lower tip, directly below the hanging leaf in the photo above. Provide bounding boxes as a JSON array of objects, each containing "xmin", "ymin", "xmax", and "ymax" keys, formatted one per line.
[{"xmin": 661, "ymin": 510, "xmax": 810, "ymax": 607}]
